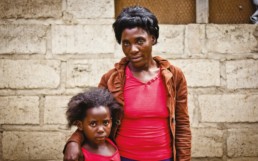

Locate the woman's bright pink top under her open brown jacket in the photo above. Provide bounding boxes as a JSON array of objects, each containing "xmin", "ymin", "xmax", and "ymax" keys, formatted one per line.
[{"xmin": 116, "ymin": 67, "xmax": 172, "ymax": 161}]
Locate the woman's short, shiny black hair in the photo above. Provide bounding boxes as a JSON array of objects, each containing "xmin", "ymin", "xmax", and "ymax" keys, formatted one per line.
[{"xmin": 113, "ymin": 6, "xmax": 159, "ymax": 44}]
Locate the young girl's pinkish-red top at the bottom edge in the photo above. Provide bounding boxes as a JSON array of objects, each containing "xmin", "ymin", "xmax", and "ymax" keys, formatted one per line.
[{"xmin": 81, "ymin": 139, "xmax": 121, "ymax": 161}]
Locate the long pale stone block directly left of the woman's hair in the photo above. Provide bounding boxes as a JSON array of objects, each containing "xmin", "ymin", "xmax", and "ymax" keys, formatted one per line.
[{"xmin": 52, "ymin": 25, "xmax": 115, "ymax": 54}]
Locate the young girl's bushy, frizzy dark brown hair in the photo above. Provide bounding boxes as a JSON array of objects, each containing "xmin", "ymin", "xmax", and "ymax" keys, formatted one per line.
[{"xmin": 66, "ymin": 87, "xmax": 121, "ymax": 128}]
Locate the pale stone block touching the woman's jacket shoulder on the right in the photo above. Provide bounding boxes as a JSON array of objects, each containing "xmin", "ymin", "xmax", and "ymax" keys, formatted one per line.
[{"xmin": 170, "ymin": 59, "xmax": 220, "ymax": 87}]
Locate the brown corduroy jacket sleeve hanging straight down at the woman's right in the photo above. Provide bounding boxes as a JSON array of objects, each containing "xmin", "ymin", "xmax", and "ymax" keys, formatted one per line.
[{"xmin": 175, "ymin": 69, "xmax": 192, "ymax": 161}]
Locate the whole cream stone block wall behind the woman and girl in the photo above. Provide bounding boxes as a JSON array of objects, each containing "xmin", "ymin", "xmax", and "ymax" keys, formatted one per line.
[{"xmin": 0, "ymin": 0, "xmax": 258, "ymax": 161}]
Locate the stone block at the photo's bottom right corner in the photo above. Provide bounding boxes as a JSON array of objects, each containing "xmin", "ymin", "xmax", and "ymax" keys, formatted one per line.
[{"xmin": 227, "ymin": 130, "xmax": 258, "ymax": 157}]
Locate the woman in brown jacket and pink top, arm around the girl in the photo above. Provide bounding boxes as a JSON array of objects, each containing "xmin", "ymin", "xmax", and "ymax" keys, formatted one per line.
[{"xmin": 64, "ymin": 6, "xmax": 191, "ymax": 161}]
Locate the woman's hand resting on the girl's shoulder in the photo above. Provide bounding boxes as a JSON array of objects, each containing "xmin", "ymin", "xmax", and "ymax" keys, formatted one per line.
[{"xmin": 63, "ymin": 142, "xmax": 83, "ymax": 161}]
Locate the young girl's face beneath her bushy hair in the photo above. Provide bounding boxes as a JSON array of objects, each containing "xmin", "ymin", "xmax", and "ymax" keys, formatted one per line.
[{"xmin": 78, "ymin": 106, "xmax": 112, "ymax": 145}]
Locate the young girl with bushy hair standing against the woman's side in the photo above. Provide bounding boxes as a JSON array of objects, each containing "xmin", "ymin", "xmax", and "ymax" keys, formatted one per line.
[{"xmin": 66, "ymin": 88, "xmax": 121, "ymax": 161}]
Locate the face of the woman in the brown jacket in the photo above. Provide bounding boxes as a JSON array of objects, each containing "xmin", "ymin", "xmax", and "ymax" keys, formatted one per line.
[{"xmin": 121, "ymin": 27, "xmax": 155, "ymax": 69}]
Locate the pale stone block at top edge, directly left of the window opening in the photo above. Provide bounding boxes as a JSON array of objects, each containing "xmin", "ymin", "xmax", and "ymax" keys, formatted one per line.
[{"xmin": 67, "ymin": 0, "xmax": 115, "ymax": 19}]
